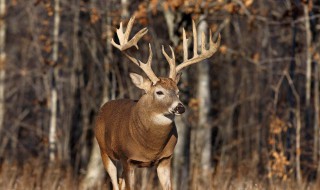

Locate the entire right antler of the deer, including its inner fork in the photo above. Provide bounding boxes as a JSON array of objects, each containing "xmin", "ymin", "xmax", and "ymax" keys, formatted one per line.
[{"xmin": 162, "ymin": 21, "xmax": 221, "ymax": 80}]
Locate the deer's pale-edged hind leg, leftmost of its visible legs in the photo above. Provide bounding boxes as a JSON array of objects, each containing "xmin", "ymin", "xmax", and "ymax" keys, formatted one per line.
[{"xmin": 101, "ymin": 151, "xmax": 119, "ymax": 190}]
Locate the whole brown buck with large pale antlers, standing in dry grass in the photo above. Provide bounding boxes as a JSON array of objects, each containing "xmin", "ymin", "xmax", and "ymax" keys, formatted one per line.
[{"xmin": 94, "ymin": 17, "xmax": 221, "ymax": 190}]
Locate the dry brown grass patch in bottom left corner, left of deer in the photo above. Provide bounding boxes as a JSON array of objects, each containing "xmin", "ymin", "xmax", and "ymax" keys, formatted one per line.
[{"xmin": 0, "ymin": 161, "xmax": 82, "ymax": 190}]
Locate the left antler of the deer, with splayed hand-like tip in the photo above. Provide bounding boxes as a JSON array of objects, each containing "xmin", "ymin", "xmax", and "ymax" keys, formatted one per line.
[{"xmin": 111, "ymin": 16, "xmax": 159, "ymax": 84}]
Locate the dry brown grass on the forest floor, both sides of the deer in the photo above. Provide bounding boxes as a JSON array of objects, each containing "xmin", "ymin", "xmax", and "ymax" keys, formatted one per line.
[{"xmin": 0, "ymin": 160, "xmax": 320, "ymax": 190}]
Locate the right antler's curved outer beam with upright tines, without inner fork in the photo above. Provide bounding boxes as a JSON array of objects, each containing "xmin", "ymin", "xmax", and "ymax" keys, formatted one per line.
[{"xmin": 173, "ymin": 21, "xmax": 221, "ymax": 75}]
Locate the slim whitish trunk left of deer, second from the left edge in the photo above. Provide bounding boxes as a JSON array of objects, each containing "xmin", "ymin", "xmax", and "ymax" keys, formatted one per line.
[{"xmin": 49, "ymin": 0, "xmax": 60, "ymax": 162}]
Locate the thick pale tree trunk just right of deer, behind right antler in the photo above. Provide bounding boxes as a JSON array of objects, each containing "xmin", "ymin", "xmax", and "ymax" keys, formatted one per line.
[{"xmin": 191, "ymin": 16, "xmax": 212, "ymax": 189}]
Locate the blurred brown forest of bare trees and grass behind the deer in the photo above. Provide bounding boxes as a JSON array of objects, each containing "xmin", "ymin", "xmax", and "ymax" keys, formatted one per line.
[{"xmin": 0, "ymin": 0, "xmax": 320, "ymax": 189}]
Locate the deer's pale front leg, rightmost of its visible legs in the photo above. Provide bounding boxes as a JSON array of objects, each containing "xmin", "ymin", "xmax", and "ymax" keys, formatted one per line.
[{"xmin": 157, "ymin": 157, "xmax": 172, "ymax": 190}]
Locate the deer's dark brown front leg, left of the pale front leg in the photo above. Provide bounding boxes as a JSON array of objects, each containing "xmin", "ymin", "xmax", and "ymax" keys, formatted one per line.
[{"xmin": 120, "ymin": 160, "xmax": 134, "ymax": 190}]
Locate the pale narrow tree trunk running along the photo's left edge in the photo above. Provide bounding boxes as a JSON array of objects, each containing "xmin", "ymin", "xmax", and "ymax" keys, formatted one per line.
[{"xmin": 0, "ymin": 0, "xmax": 6, "ymax": 132}]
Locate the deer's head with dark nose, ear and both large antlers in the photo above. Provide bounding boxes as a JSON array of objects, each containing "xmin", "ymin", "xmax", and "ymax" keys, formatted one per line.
[{"xmin": 111, "ymin": 17, "xmax": 220, "ymax": 115}]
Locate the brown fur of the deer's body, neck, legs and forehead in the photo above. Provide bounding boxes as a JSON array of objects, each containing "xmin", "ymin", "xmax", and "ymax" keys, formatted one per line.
[{"xmin": 95, "ymin": 78, "xmax": 179, "ymax": 189}]
